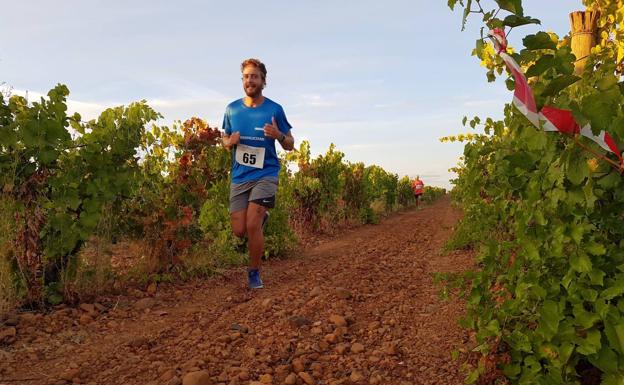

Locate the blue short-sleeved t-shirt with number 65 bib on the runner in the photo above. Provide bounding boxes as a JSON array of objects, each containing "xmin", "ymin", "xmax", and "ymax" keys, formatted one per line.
[{"xmin": 223, "ymin": 97, "xmax": 292, "ymax": 183}]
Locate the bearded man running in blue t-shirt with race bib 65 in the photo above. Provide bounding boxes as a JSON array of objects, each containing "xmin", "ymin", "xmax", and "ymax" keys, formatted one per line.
[{"xmin": 223, "ymin": 59, "xmax": 295, "ymax": 289}]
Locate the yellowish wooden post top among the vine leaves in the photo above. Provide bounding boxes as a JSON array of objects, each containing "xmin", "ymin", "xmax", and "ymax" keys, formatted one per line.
[{"xmin": 570, "ymin": 10, "xmax": 600, "ymax": 75}]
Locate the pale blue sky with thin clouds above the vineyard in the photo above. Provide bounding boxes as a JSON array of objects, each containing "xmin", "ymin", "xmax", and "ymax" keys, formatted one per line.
[{"xmin": 0, "ymin": 0, "xmax": 584, "ymax": 188}]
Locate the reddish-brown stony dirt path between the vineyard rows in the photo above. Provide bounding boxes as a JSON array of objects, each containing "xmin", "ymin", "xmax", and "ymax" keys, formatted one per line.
[{"xmin": 0, "ymin": 199, "xmax": 472, "ymax": 385}]
